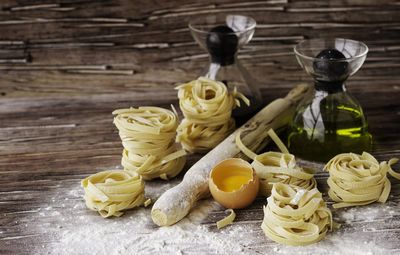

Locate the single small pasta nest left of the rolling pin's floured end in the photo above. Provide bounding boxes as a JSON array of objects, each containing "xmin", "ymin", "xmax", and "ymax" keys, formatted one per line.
[{"xmin": 81, "ymin": 170, "xmax": 146, "ymax": 218}]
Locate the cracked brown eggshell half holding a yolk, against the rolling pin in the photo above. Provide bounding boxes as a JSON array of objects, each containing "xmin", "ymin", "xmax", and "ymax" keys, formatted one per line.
[{"xmin": 209, "ymin": 158, "xmax": 259, "ymax": 209}]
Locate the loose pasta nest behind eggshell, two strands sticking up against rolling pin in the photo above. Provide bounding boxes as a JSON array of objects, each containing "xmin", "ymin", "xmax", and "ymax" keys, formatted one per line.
[{"xmin": 236, "ymin": 129, "xmax": 317, "ymax": 196}]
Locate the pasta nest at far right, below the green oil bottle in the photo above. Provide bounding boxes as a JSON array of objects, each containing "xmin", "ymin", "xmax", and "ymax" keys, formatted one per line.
[{"xmin": 324, "ymin": 152, "xmax": 400, "ymax": 208}]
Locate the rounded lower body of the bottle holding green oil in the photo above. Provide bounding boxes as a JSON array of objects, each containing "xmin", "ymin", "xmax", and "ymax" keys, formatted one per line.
[{"xmin": 288, "ymin": 87, "xmax": 372, "ymax": 162}]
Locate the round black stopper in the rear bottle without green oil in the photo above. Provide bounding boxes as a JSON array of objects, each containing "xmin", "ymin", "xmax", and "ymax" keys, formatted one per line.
[{"xmin": 207, "ymin": 25, "xmax": 238, "ymax": 66}]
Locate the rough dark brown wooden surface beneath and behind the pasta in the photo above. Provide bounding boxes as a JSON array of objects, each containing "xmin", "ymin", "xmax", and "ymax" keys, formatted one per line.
[{"xmin": 0, "ymin": 0, "xmax": 400, "ymax": 254}]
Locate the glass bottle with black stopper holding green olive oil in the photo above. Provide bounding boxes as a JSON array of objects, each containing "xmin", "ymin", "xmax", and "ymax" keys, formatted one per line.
[{"xmin": 288, "ymin": 38, "xmax": 372, "ymax": 162}]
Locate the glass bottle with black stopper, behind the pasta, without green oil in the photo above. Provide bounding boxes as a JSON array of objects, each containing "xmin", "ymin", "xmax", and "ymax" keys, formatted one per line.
[{"xmin": 189, "ymin": 15, "xmax": 262, "ymax": 124}]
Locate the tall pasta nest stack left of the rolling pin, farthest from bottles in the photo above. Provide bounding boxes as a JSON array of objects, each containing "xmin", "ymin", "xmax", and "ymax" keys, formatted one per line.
[{"xmin": 113, "ymin": 107, "xmax": 186, "ymax": 180}]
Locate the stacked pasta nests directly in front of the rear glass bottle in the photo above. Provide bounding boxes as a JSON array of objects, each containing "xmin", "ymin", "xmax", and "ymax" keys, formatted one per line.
[{"xmin": 176, "ymin": 77, "xmax": 249, "ymax": 152}]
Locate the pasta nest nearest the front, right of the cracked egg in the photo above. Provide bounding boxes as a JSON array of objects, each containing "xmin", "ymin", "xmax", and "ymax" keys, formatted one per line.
[{"xmin": 261, "ymin": 183, "xmax": 334, "ymax": 246}]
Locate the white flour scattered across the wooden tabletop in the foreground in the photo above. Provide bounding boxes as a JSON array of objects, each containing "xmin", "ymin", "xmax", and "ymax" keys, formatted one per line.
[{"xmin": 27, "ymin": 180, "xmax": 400, "ymax": 255}]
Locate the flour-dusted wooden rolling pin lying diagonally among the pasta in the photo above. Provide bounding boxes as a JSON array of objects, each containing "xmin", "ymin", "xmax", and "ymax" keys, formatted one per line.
[{"xmin": 151, "ymin": 84, "xmax": 310, "ymax": 226}]
